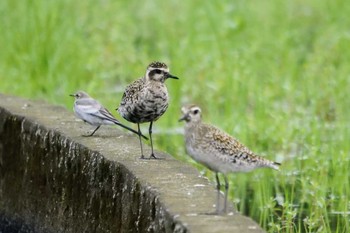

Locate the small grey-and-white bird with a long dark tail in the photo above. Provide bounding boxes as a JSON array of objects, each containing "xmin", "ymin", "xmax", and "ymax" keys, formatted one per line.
[{"xmin": 70, "ymin": 91, "xmax": 148, "ymax": 140}]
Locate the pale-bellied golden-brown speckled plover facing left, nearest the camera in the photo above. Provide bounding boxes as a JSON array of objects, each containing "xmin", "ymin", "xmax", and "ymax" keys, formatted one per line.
[{"xmin": 180, "ymin": 105, "xmax": 280, "ymax": 214}]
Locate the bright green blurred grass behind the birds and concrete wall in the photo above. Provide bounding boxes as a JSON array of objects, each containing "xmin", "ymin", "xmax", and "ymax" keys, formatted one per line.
[{"xmin": 0, "ymin": 0, "xmax": 350, "ymax": 233}]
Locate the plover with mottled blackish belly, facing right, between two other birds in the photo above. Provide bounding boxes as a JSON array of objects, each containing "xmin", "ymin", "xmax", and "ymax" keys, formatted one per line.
[{"xmin": 117, "ymin": 62, "xmax": 178, "ymax": 159}]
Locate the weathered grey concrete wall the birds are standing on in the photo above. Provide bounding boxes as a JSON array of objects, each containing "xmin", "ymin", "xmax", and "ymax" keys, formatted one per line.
[{"xmin": 0, "ymin": 95, "xmax": 262, "ymax": 233}]
